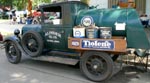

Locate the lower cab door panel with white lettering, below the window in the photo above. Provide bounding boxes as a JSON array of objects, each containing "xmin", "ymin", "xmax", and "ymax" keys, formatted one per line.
[{"xmin": 43, "ymin": 25, "xmax": 66, "ymax": 50}]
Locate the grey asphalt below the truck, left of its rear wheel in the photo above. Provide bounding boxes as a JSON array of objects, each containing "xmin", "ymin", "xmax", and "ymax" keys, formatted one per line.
[{"xmin": 0, "ymin": 50, "xmax": 94, "ymax": 83}]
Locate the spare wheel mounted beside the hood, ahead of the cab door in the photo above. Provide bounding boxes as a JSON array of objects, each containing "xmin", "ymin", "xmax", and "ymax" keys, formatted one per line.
[{"xmin": 21, "ymin": 31, "xmax": 43, "ymax": 57}]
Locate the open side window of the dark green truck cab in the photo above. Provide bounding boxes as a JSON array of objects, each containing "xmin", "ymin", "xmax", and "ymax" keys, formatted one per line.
[{"xmin": 43, "ymin": 6, "xmax": 62, "ymax": 25}]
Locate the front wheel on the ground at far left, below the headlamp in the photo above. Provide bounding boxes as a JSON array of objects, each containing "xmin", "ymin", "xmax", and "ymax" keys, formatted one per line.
[{"xmin": 5, "ymin": 41, "xmax": 22, "ymax": 64}]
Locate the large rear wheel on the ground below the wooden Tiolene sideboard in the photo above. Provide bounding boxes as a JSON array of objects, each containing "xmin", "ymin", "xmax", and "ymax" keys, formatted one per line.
[{"xmin": 80, "ymin": 51, "xmax": 113, "ymax": 82}]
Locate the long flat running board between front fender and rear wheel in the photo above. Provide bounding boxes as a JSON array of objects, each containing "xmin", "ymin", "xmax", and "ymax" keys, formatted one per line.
[{"xmin": 32, "ymin": 56, "xmax": 79, "ymax": 65}]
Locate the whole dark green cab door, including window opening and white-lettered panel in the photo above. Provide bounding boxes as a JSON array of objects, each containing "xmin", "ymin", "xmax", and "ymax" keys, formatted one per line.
[{"xmin": 42, "ymin": 4, "xmax": 66, "ymax": 50}]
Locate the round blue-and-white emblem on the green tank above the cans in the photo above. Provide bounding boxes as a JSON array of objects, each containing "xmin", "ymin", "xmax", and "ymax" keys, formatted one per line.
[{"xmin": 81, "ymin": 16, "xmax": 94, "ymax": 27}]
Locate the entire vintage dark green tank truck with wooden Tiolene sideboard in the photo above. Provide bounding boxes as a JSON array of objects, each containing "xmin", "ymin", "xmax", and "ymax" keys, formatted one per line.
[{"xmin": 5, "ymin": 1, "xmax": 150, "ymax": 81}]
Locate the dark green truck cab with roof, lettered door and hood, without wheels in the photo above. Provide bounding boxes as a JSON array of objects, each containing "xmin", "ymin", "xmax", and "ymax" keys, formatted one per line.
[{"xmin": 22, "ymin": 2, "xmax": 88, "ymax": 51}]
